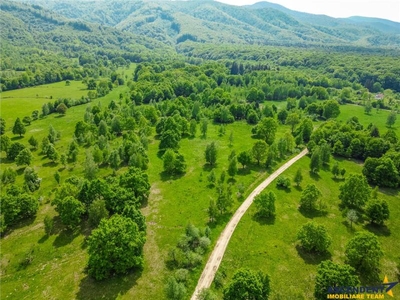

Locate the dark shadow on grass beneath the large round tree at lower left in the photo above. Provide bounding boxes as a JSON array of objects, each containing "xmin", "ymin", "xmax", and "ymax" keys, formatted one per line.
[{"xmin": 76, "ymin": 270, "xmax": 142, "ymax": 300}]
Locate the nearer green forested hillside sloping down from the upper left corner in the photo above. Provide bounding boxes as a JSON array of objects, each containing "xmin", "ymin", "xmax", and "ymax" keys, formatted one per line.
[{"xmin": 0, "ymin": 1, "xmax": 173, "ymax": 70}]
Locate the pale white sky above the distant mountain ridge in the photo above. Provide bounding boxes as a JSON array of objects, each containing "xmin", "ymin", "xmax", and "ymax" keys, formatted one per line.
[{"xmin": 217, "ymin": 0, "xmax": 400, "ymax": 22}]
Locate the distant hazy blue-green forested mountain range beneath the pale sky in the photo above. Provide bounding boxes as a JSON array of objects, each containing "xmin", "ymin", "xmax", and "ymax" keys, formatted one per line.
[{"xmin": 10, "ymin": 0, "xmax": 400, "ymax": 48}]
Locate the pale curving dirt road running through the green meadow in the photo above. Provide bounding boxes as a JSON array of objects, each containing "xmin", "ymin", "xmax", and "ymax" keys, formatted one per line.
[{"xmin": 191, "ymin": 149, "xmax": 308, "ymax": 300}]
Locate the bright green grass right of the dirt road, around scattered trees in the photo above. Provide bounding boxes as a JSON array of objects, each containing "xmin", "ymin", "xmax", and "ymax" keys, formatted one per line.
[{"xmin": 221, "ymin": 157, "xmax": 400, "ymax": 299}]
